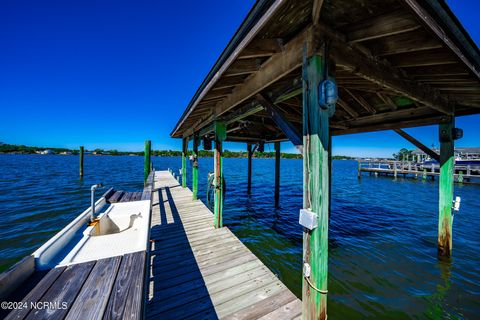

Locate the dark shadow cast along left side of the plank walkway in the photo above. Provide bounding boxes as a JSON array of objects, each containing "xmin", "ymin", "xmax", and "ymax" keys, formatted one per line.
[{"xmin": 146, "ymin": 187, "xmax": 218, "ymax": 319}]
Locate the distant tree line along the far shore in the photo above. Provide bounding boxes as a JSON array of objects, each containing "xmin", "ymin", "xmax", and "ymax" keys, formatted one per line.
[{"xmin": 0, "ymin": 143, "xmax": 353, "ymax": 160}]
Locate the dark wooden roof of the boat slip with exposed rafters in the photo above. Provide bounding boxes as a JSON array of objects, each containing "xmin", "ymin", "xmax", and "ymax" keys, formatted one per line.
[{"xmin": 172, "ymin": 0, "xmax": 480, "ymax": 142}]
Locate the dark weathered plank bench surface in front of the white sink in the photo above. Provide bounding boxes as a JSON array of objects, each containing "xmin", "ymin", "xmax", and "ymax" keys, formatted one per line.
[{"xmin": 5, "ymin": 251, "xmax": 146, "ymax": 320}]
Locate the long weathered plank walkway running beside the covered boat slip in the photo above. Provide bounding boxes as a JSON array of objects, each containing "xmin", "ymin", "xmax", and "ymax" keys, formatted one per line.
[{"xmin": 146, "ymin": 171, "xmax": 301, "ymax": 319}]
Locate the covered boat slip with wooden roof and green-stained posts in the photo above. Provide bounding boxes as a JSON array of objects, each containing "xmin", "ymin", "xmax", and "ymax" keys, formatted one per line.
[{"xmin": 171, "ymin": 0, "xmax": 480, "ymax": 319}]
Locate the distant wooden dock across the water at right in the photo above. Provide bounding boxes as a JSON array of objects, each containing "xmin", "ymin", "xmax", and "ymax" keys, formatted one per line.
[{"xmin": 358, "ymin": 160, "xmax": 480, "ymax": 184}]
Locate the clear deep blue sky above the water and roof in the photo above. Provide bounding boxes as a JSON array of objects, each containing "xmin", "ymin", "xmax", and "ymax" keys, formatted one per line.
[{"xmin": 0, "ymin": 0, "xmax": 480, "ymax": 156}]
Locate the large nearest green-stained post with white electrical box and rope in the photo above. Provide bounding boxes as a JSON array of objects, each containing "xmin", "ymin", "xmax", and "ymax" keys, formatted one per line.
[{"xmin": 302, "ymin": 55, "xmax": 334, "ymax": 320}]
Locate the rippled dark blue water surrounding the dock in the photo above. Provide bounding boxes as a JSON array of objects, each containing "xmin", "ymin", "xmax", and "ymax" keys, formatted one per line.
[{"xmin": 0, "ymin": 155, "xmax": 480, "ymax": 319}]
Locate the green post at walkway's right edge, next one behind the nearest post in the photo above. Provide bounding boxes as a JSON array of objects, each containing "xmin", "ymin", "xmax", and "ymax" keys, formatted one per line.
[{"xmin": 213, "ymin": 121, "xmax": 227, "ymax": 228}]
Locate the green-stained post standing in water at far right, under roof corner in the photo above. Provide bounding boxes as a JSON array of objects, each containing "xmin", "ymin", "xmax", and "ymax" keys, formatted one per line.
[{"xmin": 438, "ymin": 117, "xmax": 455, "ymax": 257}]
